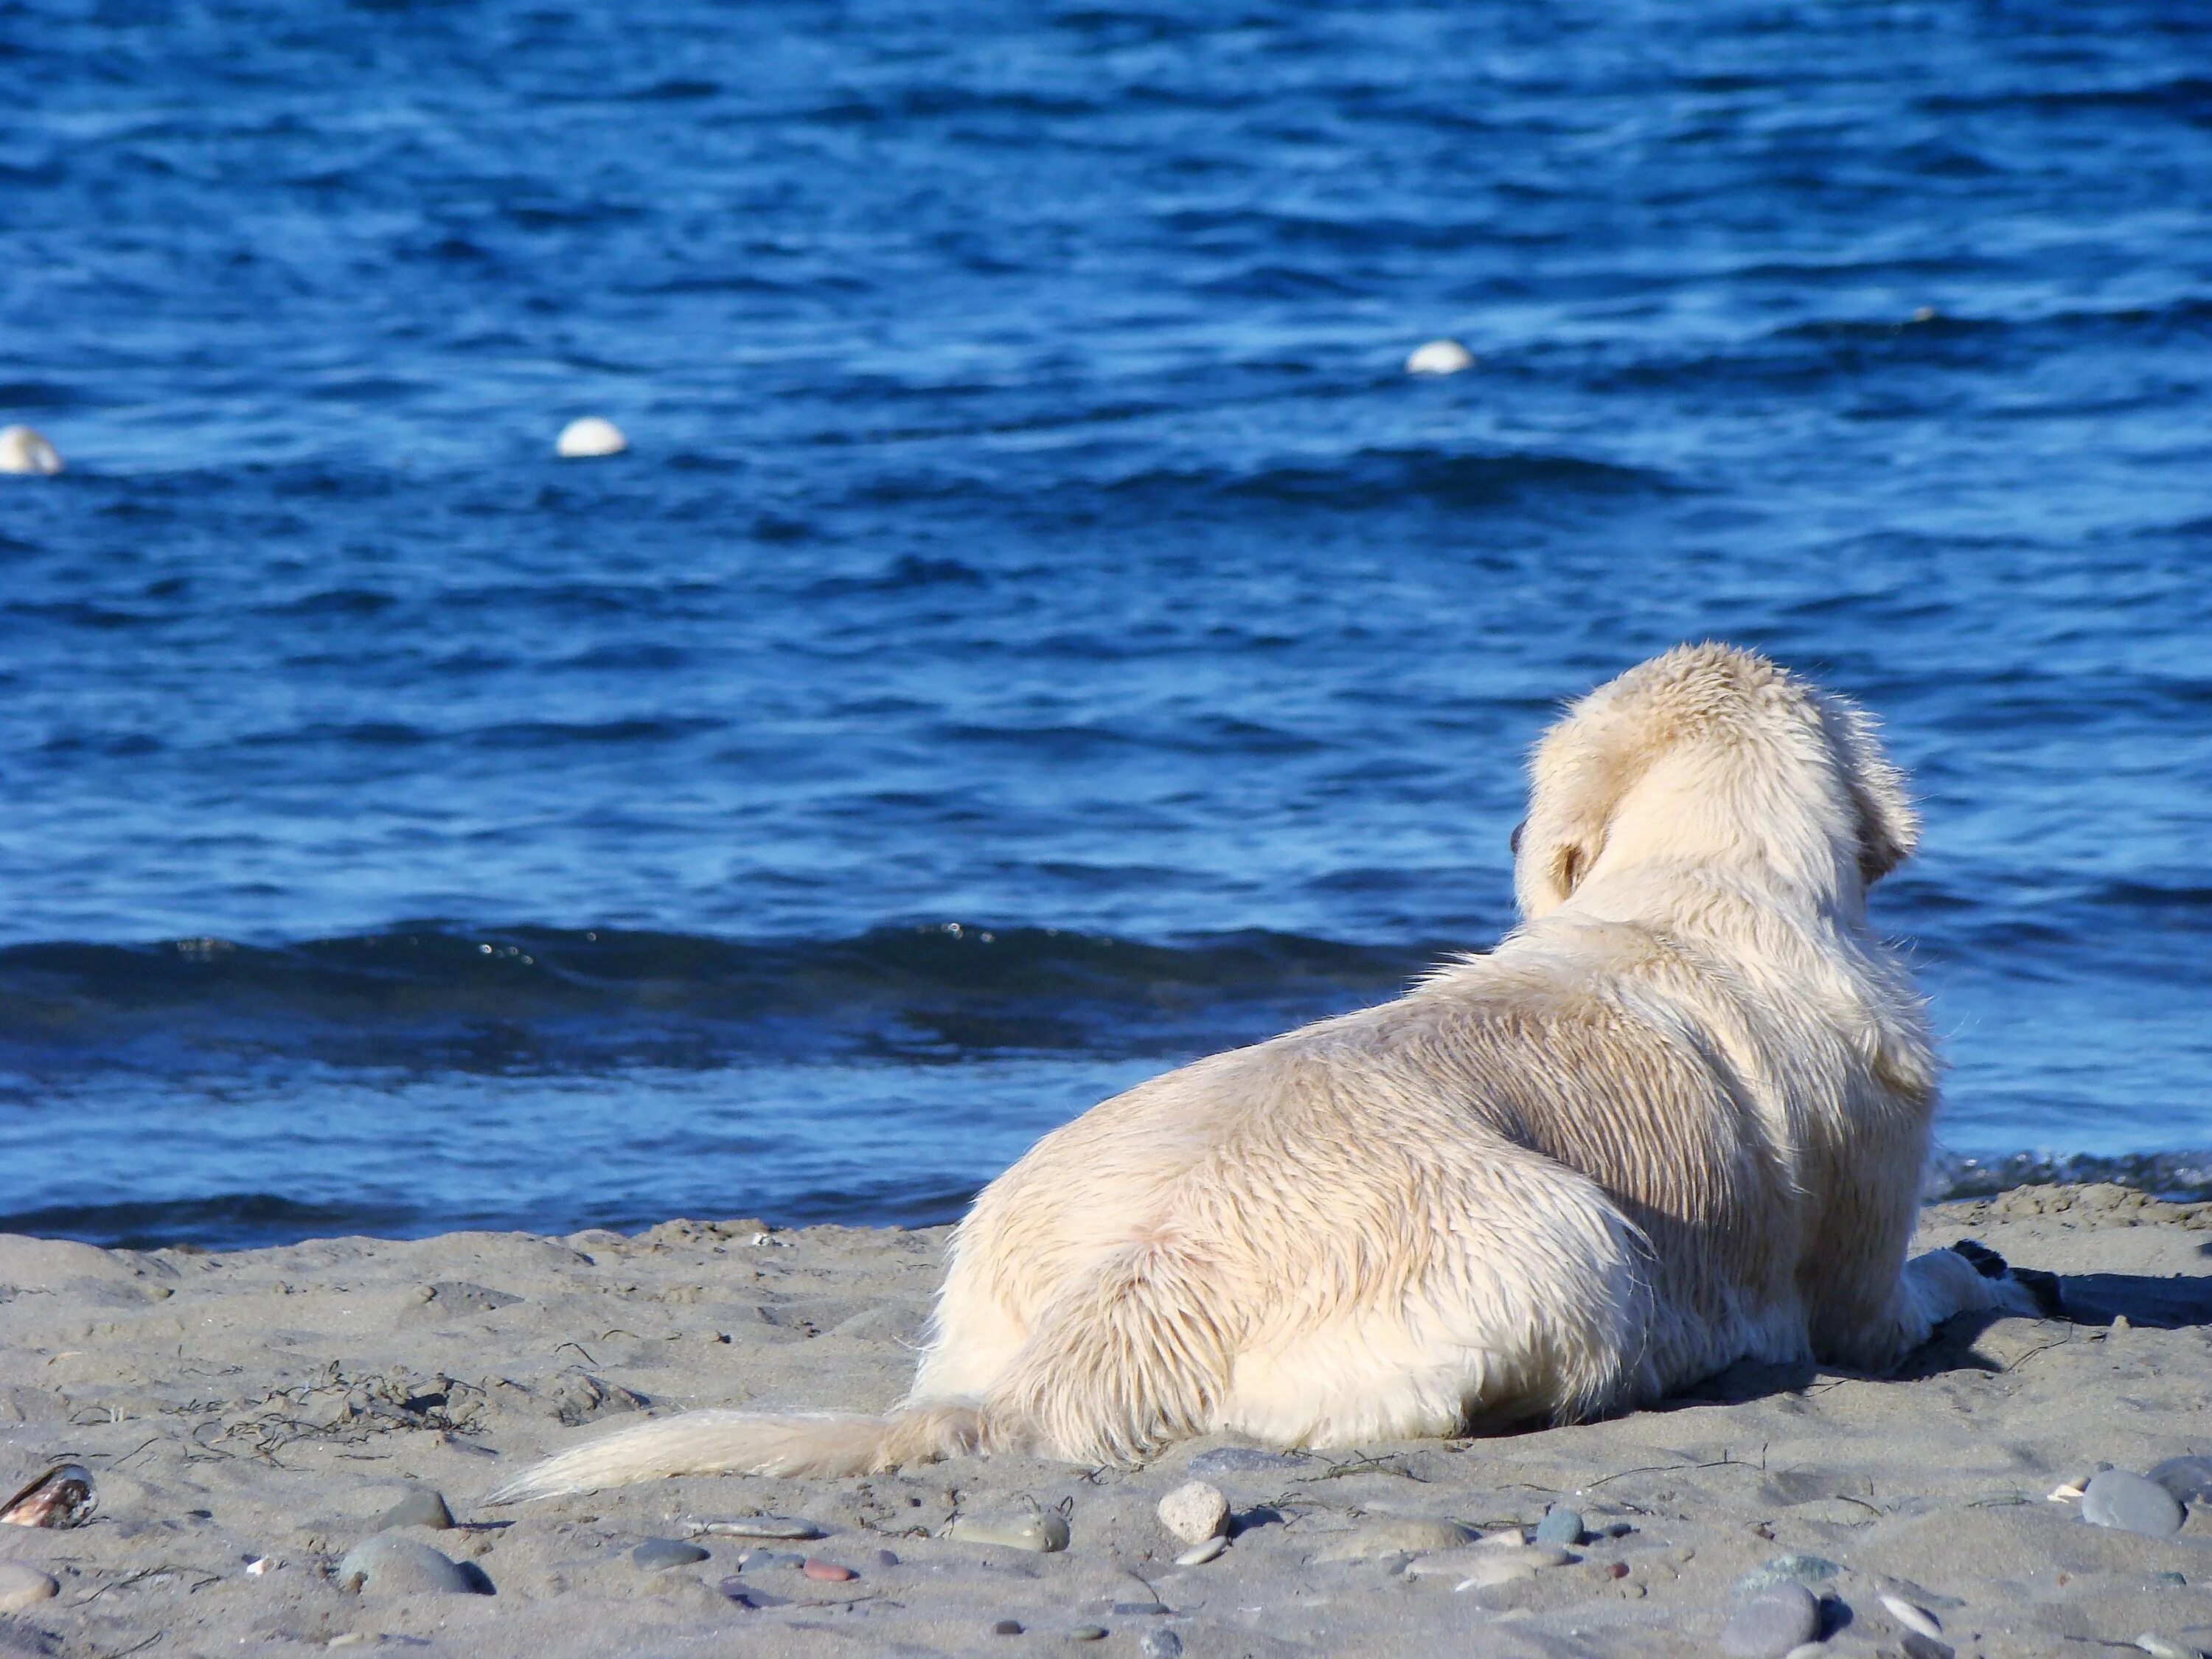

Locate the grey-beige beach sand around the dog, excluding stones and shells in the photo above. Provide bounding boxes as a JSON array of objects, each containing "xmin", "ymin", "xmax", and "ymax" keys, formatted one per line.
[{"xmin": 0, "ymin": 1188, "xmax": 2212, "ymax": 1659}]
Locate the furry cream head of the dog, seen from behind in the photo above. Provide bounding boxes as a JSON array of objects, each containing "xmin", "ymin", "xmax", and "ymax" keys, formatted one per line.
[{"xmin": 1513, "ymin": 644, "xmax": 1920, "ymax": 920}]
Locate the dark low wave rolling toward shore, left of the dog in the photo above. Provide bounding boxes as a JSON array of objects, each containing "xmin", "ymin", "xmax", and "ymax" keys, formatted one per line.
[{"xmin": 0, "ymin": 922, "xmax": 1444, "ymax": 1077}]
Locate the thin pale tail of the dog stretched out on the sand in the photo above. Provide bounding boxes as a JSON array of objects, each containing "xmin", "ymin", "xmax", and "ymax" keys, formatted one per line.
[{"xmin": 484, "ymin": 1405, "xmax": 984, "ymax": 1504}]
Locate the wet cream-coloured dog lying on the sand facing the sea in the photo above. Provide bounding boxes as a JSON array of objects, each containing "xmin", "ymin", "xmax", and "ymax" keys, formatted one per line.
[{"xmin": 493, "ymin": 644, "xmax": 2037, "ymax": 1502}]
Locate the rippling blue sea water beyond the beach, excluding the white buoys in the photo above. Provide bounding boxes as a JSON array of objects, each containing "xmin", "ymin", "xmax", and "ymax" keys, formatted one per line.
[{"xmin": 0, "ymin": 0, "xmax": 2212, "ymax": 1243}]
